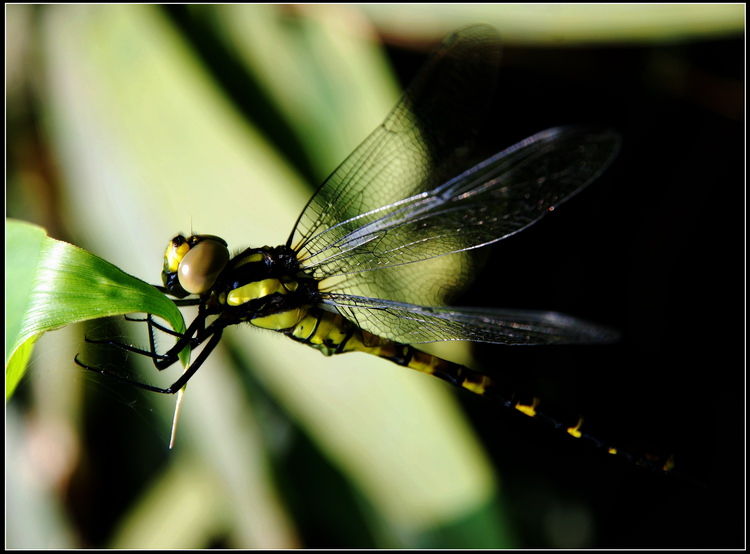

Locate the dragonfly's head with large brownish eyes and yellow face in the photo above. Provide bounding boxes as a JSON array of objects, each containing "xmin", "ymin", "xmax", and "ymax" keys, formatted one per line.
[{"xmin": 161, "ymin": 235, "xmax": 229, "ymax": 298}]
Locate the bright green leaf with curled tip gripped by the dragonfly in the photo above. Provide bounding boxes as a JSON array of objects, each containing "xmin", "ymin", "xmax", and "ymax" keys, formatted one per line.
[{"xmin": 5, "ymin": 220, "xmax": 189, "ymax": 400}]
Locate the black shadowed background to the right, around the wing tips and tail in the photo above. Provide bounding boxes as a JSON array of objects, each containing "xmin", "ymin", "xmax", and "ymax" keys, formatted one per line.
[{"xmin": 463, "ymin": 35, "xmax": 745, "ymax": 548}]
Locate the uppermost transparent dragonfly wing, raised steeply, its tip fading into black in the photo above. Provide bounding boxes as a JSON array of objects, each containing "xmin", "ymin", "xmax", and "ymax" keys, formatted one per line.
[{"xmin": 287, "ymin": 25, "xmax": 500, "ymax": 251}]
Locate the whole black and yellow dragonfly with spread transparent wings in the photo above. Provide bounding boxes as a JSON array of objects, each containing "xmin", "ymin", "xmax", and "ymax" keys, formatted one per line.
[{"xmin": 76, "ymin": 25, "xmax": 672, "ymax": 471}]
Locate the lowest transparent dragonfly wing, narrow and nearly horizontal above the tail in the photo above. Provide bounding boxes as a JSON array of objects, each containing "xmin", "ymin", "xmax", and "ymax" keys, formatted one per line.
[{"xmin": 324, "ymin": 294, "xmax": 617, "ymax": 345}]
